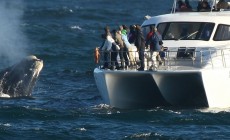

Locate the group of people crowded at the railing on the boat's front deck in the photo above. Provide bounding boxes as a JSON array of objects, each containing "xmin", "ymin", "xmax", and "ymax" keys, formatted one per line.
[{"xmin": 99, "ymin": 25, "xmax": 162, "ymax": 71}]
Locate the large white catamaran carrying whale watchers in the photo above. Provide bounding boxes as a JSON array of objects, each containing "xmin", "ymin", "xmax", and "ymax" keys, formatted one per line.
[{"xmin": 94, "ymin": 0, "xmax": 230, "ymax": 109}]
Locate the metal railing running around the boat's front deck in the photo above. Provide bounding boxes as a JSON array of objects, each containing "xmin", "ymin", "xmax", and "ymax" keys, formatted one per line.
[{"xmin": 97, "ymin": 47, "xmax": 230, "ymax": 70}]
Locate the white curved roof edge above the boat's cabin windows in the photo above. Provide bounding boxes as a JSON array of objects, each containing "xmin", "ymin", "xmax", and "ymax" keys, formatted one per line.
[{"xmin": 142, "ymin": 11, "xmax": 230, "ymax": 27}]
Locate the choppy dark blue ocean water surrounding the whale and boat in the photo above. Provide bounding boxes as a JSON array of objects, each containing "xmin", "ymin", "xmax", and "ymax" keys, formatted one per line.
[{"xmin": 0, "ymin": 0, "xmax": 230, "ymax": 140}]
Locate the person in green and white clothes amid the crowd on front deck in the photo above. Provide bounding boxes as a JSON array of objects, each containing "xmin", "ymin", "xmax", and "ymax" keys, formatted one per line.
[{"xmin": 121, "ymin": 26, "xmax": 135, "ymax": 68}]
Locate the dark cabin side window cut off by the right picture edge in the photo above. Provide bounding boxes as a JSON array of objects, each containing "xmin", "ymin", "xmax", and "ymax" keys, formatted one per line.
[{"xmin": 213, "ymin": 24, "xmax": 230, "ymax": 41}]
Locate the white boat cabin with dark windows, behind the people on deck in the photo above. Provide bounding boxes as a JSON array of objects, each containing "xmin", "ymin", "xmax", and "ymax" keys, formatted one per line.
[{"xmin": 142, "ymin": 0, "xmax": 230, "ymax": 48}]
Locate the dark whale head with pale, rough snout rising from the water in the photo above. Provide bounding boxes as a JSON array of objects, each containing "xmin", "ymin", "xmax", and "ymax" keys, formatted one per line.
[{"xmin": 0, "ymin": 55, "xmax": 43, "ymax": 98}]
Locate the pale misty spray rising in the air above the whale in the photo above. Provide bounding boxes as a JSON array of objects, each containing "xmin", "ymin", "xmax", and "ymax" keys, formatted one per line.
[{"xmin": 0, "ymin": 0, "xmax": 27, "ymax": 68}]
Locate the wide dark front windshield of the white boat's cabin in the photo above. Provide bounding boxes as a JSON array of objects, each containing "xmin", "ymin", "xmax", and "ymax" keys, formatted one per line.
[{"xmin": 155, "ymin": 22, "xmax": 215, "ymax": 41}]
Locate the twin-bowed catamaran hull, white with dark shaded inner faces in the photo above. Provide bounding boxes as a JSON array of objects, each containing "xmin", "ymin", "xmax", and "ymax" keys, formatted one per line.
[{"xmin": 94, "ymin": 68, "xmax": 230, "ymax": 108}]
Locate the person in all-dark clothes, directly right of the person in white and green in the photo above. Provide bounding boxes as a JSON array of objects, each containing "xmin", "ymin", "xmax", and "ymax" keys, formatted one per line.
[{"xmin": 135, "ymin": 25, "xmax": 145, "ymax": 71}]
